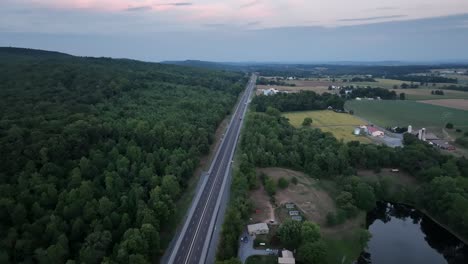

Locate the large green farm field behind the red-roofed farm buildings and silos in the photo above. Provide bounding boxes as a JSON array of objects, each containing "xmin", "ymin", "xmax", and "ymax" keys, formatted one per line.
[{"xmin": 345, "ymin": 100, "xmax": 468, "ymax": 133}]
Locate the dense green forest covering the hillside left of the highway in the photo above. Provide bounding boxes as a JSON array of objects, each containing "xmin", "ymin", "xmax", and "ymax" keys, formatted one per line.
[{"xmin": 0, "ymin": 48, "xmax": 247, "ymax": 264}]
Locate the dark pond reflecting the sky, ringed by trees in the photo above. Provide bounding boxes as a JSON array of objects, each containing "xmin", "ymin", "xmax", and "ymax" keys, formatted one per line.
[{"xmin": 357, "ymin": 203, "xmax": 468, "ymax": 264}]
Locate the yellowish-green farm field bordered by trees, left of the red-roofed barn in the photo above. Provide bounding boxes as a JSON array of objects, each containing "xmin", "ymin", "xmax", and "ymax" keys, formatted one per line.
[{"xmin": 284, "ymin": 110, "xmax": 372, "ymax": 143}]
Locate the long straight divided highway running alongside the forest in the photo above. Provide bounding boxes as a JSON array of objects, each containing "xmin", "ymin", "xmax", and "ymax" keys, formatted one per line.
[{"xmin": 167, "ymin": 75, "xmax": 257, "ymax": 264}]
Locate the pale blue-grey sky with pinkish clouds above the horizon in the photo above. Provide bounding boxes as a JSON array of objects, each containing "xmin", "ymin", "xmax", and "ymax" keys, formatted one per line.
[{"xmin": 0, "ymin": 0, "xmax": 468, "ymax": 62}]
